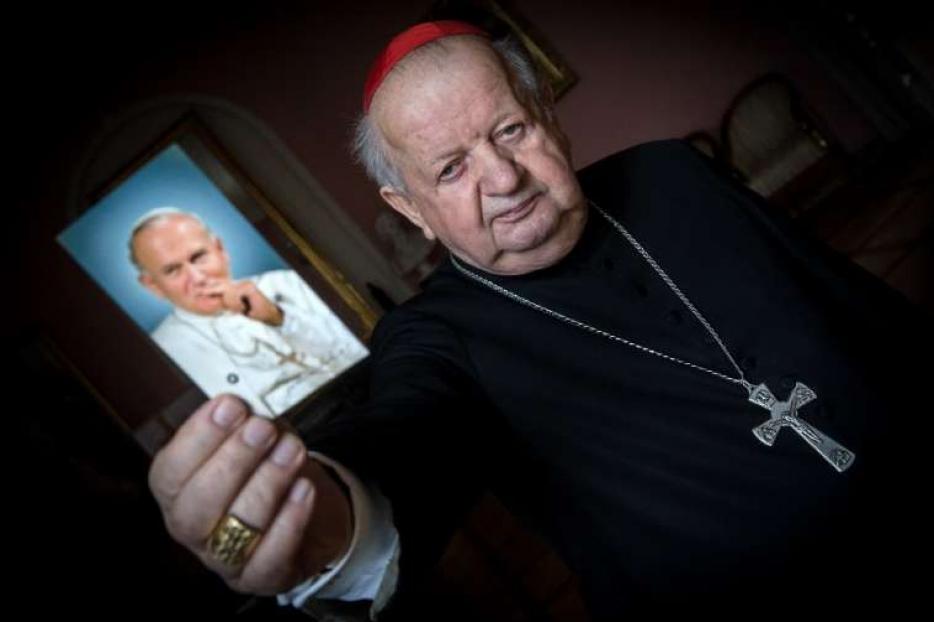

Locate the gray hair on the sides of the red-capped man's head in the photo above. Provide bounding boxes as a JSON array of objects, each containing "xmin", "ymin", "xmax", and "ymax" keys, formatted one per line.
[{"xmin": 351, "ymin": 36, "xmax": 554, "ymax": 191}]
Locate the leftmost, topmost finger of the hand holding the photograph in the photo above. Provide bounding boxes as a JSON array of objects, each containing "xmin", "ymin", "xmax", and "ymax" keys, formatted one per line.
[{"xmin": 149, "ymin": 395, "xmax": 249, "ymax": 508}]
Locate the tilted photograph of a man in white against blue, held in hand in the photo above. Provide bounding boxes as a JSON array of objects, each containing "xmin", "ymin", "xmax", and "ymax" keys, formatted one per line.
[{"xmin": 59, "ymin": 135, "xmax": 368, "ymax": 417}]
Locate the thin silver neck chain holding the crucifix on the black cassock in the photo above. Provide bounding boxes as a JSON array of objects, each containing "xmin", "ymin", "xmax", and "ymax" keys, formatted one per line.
[{"xmin": 451, "ymin": 201, "xmax": 754, "ymax": 394}]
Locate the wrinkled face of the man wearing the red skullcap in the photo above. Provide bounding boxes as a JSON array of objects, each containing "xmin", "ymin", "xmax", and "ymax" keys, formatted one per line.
[{"xmin": 370, "ymin": 37, "xmax": 586, "ymax": 274}]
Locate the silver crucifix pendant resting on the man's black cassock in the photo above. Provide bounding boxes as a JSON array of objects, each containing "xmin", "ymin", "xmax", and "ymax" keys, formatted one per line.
[{"xmin": 749, "ymin": 382, "xmax": 856, "ymax": 473}]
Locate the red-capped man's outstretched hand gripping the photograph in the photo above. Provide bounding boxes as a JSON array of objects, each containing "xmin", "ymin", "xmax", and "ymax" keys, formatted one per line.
[{"xmin": 149, "ymin": 395, "xmax": 352, "ymax": 595}]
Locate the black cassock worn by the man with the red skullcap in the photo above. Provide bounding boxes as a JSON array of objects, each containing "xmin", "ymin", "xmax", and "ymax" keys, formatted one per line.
[{"xmin": 312, "ymin": 141, "xmax": 934, "ymax": 619}]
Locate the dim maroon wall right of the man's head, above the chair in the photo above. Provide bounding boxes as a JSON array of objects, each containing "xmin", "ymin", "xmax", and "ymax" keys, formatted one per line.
[{"xmin": 526, "ymin": 0, "xmax": 872, "ymax": 165}]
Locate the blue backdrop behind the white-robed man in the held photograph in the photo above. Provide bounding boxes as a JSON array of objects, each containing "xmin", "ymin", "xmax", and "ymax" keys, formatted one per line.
[{"xmin": 58, "ymin": 144, "xmax": 289, "ymax": 333}]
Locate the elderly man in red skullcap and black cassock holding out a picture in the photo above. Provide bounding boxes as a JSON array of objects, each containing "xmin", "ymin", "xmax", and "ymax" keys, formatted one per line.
[{"xmin": 151, "ymin": 22, "xmax": 930, "ymax": 620}]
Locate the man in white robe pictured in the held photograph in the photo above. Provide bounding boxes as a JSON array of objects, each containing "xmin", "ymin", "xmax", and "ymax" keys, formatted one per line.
[{"xmin": 129, "ymin": 208, "xmax": 367, "ymax": 416}]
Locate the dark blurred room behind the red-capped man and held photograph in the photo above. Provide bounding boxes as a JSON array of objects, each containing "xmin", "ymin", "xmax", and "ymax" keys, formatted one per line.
[{"xmin": 9, "ymin": 0, "xmax": 934, "ymax": 620}]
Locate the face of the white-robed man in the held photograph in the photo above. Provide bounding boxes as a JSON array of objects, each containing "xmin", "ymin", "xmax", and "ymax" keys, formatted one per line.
[{"xmin": 133, "ymin": 215, "xmax": 230, "ymax": 315}]
